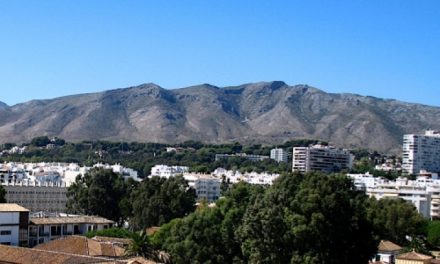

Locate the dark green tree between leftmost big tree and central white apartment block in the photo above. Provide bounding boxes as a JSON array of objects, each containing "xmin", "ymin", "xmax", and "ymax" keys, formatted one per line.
[{"xmin": 131, "ymin": 176, "xmax": 196, "ymax": 229}]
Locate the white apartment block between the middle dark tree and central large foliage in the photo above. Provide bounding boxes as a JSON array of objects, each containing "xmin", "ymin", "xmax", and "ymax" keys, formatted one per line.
[{"xmin": 183, "ymin": 173, "xmax": 221, "ymax": 203}]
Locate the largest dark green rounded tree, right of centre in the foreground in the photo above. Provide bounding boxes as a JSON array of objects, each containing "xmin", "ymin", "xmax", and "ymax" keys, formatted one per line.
[{"xmin": 238, "ymin": 173, "xmax": 377, "ymax": 264}]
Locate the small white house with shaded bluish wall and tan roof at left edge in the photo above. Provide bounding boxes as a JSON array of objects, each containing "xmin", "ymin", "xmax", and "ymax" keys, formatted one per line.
[{"xmin": 0, "ymin": 203, "xmax": 29, "ymax": 246}]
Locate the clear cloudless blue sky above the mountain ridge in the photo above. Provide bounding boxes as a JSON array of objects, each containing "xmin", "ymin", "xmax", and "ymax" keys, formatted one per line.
[{"xmin": 0, "ymin": 0, "xmax": 440, "ymax": 106}]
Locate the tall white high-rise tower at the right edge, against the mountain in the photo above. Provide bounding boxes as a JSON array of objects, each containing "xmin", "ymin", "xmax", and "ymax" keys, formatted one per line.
[{"xmin": 402, "ymin": 130, "xmax": 440, "ymax": 175}]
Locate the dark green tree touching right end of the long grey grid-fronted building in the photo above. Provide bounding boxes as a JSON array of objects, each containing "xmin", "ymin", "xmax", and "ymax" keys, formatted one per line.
[{"xmin": 67, "ymin": 169, "xmax": 129, "ymax": 223}]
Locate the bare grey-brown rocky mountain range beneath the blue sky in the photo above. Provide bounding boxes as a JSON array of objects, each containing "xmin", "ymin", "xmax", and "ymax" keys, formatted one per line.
[{"xmin": 0, "ymin": 81, "xmax": 440, "ymax": 151}]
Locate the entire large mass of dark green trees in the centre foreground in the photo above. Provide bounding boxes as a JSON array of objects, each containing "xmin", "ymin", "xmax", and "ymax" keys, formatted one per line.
[{"xmin": 154, "ymin": 173, "xmax": 384, "ymax": 263}]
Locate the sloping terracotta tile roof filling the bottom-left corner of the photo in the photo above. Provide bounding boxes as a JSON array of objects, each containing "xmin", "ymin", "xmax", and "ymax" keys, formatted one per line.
[{"xmin": 0, "ymin": 245, "xmax": 122, "ymax": 264}]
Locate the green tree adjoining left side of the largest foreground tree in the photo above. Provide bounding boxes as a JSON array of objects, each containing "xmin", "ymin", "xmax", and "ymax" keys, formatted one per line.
[{"xmin": 153, "ymin": 183, "xmax": 264, "ymax": 263}]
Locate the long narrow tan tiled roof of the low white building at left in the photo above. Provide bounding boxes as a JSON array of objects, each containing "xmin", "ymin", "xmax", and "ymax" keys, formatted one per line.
[{"xmin": 30, "ymin": 216, "xmax": 115, "ymax": 225}]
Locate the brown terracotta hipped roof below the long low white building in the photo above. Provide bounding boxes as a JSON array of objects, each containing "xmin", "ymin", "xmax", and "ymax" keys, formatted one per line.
[{"xmin": 35, "ymin": 236, "xmax": 125, "ymax": 257}]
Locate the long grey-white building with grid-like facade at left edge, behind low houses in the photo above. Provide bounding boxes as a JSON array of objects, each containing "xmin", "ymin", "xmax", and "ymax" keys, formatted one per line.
[{"xmin": 1, "ymin": 180, "xmax": 67, "ymax": 212}]
